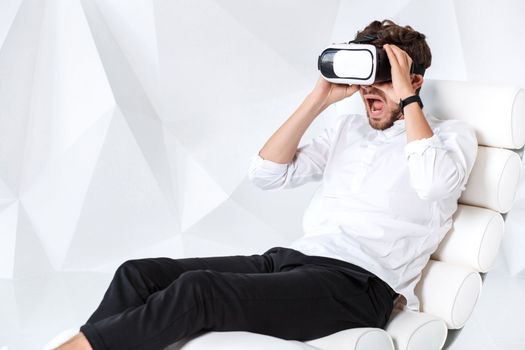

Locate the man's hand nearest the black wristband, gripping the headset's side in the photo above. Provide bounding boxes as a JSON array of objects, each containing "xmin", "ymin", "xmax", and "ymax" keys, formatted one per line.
[{"xmin": 383, "ymin": 44, "xmax": 416, "ymax": 100}]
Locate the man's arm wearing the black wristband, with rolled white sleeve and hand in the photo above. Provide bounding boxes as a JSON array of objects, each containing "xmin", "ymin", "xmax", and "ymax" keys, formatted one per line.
[{"xmin": 384, "ymin": 45, "xmax": 478, "ymax": 200}]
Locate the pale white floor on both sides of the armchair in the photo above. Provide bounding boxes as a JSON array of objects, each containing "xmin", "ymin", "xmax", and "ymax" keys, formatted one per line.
[{"xmin": 0, "ymin": 252, "xmax": 525, "ymax": 350}]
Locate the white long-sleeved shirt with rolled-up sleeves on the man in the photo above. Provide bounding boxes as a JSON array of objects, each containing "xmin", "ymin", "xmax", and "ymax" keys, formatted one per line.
[{"xmin": 248, "ymin": 114, "xmax": 478, "ymax": 311}]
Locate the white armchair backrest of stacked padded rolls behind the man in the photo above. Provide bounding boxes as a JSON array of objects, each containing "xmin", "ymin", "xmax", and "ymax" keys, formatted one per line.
[{"xmin": 416, "ymin": 80, "xmax": 525, "ymax": 329}]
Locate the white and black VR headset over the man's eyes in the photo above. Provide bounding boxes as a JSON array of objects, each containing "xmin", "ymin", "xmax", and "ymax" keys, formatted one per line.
[{"xmin": 317, "ymin": 35, "xmax": 425, "ymax": 85}]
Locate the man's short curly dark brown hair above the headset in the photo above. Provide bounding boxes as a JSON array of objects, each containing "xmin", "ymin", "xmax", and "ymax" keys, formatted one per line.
[{"xmin": 354, "ymin": 19, "xmax": 432, "ymax": 92}]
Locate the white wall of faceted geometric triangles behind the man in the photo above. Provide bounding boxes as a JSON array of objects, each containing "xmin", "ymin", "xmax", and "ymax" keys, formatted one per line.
[{"xmin": 0, "ymin": 0, "xmax": 525, "ymax": 286}]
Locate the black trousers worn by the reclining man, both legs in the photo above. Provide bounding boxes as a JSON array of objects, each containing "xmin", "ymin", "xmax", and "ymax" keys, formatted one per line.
[{"xmin": 80, "ymin": 247, "xmax": 398, "ymax": 350}]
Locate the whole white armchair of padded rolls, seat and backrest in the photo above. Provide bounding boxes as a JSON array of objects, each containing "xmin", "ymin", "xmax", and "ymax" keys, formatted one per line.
[{"xmin": 164, "ymin": 80, "xmax": 525, "ymax": 350}]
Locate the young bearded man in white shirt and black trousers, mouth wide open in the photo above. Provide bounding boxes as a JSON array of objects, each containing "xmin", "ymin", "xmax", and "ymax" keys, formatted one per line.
[{"xmin": 55, "ymin": 21, "xmax": 477, "ymax": 350}]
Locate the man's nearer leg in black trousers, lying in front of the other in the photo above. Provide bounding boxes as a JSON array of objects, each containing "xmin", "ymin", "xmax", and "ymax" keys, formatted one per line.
[{"xmin": 81, "ymin": 264, "xmax": 392, "ymax": 350}]
